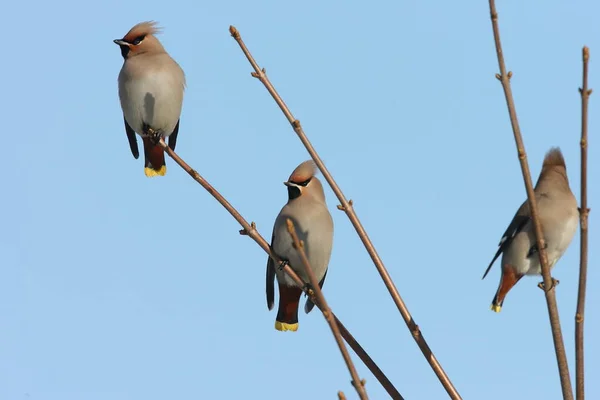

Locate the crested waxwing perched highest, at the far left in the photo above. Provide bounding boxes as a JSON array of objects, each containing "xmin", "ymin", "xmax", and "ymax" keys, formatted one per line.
[{"xmin": 114, "ymin": 21, "xmax": 185, "ymax": 177}]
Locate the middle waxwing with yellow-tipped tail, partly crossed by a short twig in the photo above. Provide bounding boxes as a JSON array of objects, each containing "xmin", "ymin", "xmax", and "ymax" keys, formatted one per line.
[{"xmin": 267, "ymin": 161, "xmax": 333, "ymax": 331}]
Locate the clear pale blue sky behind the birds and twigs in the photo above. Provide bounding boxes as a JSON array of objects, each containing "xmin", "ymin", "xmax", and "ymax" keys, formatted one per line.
[{"xmin": 0, "ymin": 0, "xmax": 600, "ymax": 400}]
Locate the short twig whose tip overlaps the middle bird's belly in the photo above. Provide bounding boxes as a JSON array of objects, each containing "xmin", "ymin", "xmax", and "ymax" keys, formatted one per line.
[{"xmin": 287, "ymin": 218, "xmax": 369, "ymax": 400}]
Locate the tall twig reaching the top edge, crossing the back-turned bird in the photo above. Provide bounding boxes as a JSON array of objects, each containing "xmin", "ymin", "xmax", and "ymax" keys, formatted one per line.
[{"xmin": 489, "ymin": 0, "xmax": 573, "ymax": 400}]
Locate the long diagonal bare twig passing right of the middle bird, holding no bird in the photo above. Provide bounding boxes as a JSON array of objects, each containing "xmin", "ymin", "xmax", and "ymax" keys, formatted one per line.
[{"xmin": 229, "ymin": 26, "xmax": 461, "ymax": 400}]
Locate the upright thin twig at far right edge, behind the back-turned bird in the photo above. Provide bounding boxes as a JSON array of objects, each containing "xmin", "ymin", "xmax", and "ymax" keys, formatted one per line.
[{"xmin": 575, "ymin": 46, "xmax": 592, "ymax": 400}]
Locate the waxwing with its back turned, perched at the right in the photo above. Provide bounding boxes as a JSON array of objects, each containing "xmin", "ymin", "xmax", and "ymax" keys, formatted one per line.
[{"xmin": 482, "ymin": 148, "xmax": 579, "ymax": 312}]
